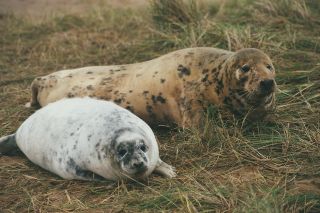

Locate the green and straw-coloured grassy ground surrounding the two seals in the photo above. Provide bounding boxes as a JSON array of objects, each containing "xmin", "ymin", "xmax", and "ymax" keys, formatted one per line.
[{"xmin": 0, "ymin": 0, "xmax": 320, "ymax": 212}]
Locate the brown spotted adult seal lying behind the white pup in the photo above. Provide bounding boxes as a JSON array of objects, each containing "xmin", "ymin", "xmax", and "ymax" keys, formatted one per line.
[{"xmin": 29, "ymin": 47, "xmax": 276, "ymax": 127}]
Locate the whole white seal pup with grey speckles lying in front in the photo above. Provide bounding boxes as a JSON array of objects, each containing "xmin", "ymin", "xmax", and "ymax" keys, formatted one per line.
[{"xmin": 0, "ymin": 98, "xmax": 175, "ymax": 180}]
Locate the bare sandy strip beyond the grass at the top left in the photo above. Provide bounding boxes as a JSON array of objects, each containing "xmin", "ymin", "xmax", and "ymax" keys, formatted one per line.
[{"xmin": 0, "ymin": 0, "xmax": 148, "ymax": 19}]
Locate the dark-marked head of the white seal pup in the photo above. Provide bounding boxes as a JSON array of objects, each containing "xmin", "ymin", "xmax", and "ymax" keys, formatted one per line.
[{"xmin": 111, "ymin": 128, "xmax": 150, "ymax": 179}]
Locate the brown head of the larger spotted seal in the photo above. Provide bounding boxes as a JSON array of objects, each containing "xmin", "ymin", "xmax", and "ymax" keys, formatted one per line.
[{"xmin": 228, "ymin": 48, "xmax": 276, "ymax": 115}]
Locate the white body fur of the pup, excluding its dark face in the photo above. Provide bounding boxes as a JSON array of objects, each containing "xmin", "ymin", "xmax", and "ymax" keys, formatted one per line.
[{"xmin": 16, "ymin": 98, "xmax": 174, "ymax": 180}]
